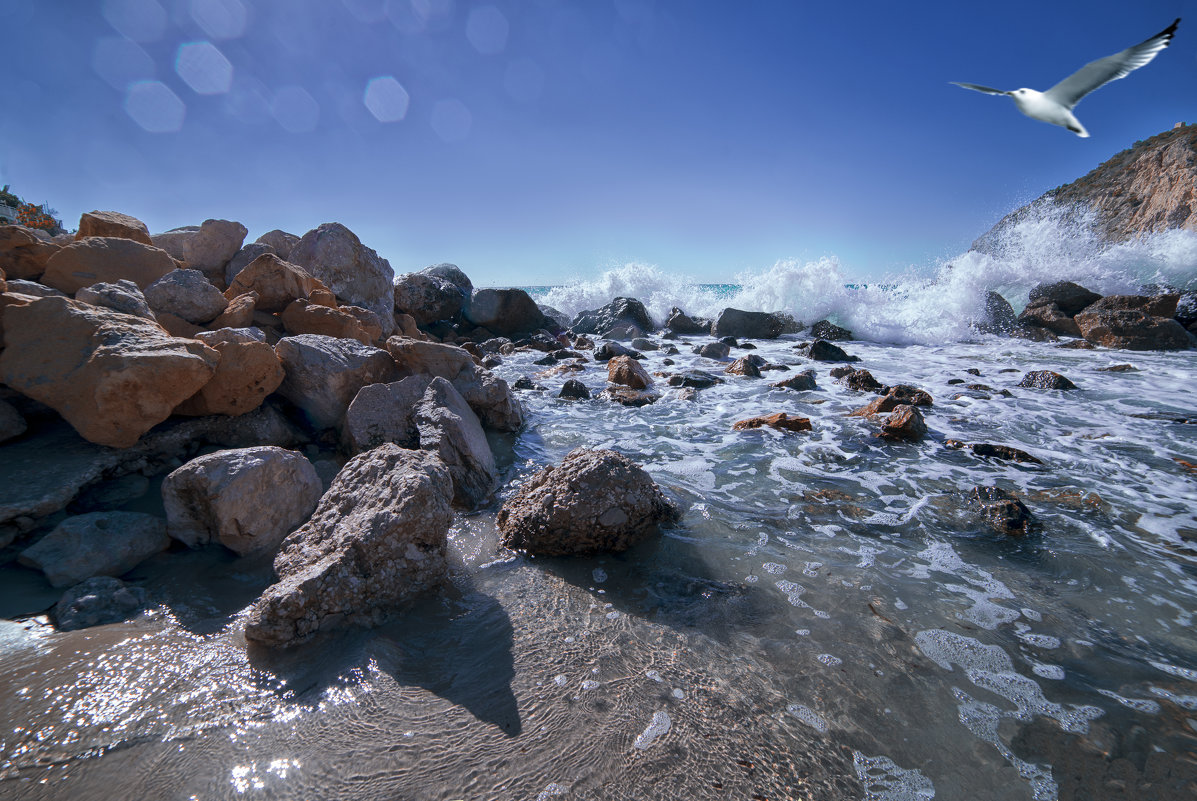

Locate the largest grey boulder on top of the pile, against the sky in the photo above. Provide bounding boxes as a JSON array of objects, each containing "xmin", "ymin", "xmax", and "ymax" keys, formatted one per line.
[{"xmin": 287, "ymin": 223, "xmax": 395, "ymax": 334}]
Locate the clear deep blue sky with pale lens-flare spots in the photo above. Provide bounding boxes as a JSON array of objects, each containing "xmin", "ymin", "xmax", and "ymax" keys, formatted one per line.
[{"xmin": 0, "ymin": 0, "xmax": 1197, "ymax": 285}]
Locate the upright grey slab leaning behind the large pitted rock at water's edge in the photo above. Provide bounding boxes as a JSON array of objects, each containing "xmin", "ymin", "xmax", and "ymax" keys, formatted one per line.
[{"xmin": 412, "ymin": 377, "xmax": 498, "ymax": 509}]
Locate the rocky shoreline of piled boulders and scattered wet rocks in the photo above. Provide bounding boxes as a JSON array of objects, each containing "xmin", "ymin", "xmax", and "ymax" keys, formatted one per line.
[{"xmin": 0, "ymin": 212, "xmax": 1197, "ymax": 647}]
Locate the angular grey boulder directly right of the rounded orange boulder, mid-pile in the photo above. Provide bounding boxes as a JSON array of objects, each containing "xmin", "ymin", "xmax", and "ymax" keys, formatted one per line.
[{"xmin": 274, "ymin": 334, "xmax": 399, "ymax": 429}]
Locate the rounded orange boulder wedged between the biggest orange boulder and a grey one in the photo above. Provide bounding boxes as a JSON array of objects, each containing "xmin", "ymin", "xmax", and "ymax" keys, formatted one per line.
[{"xmin": 175, "ymin": 328, "xmax": 285, "ymax": 417}]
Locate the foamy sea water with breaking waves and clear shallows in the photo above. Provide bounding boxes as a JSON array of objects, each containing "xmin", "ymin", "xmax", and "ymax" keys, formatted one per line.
[{"xmin": 0, "ymin": 203, "xmax": 1197, "ymax": 801}]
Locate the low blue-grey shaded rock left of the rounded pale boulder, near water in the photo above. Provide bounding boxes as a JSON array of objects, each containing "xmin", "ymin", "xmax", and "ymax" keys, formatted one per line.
[{"xmin": 17, "ymin": 511, "xmax": 170, "ymax": 587}]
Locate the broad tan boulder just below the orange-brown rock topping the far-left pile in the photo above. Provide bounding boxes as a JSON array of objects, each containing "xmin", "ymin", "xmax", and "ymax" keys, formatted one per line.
[{"xmin": 41, "ymin": 236, "xmax": 177, "ymax": 295}]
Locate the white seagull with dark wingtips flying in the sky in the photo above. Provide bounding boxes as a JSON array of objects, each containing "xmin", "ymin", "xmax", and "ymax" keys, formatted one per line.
[{"xmin": 950, "ymin": 17, "xmax": 1180, "ymax": 139}]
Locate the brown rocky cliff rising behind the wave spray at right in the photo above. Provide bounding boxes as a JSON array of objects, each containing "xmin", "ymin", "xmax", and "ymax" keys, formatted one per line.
[{"xmin": 972, "ymin": 125, "xmax": 1197, "ymax": 251}]
